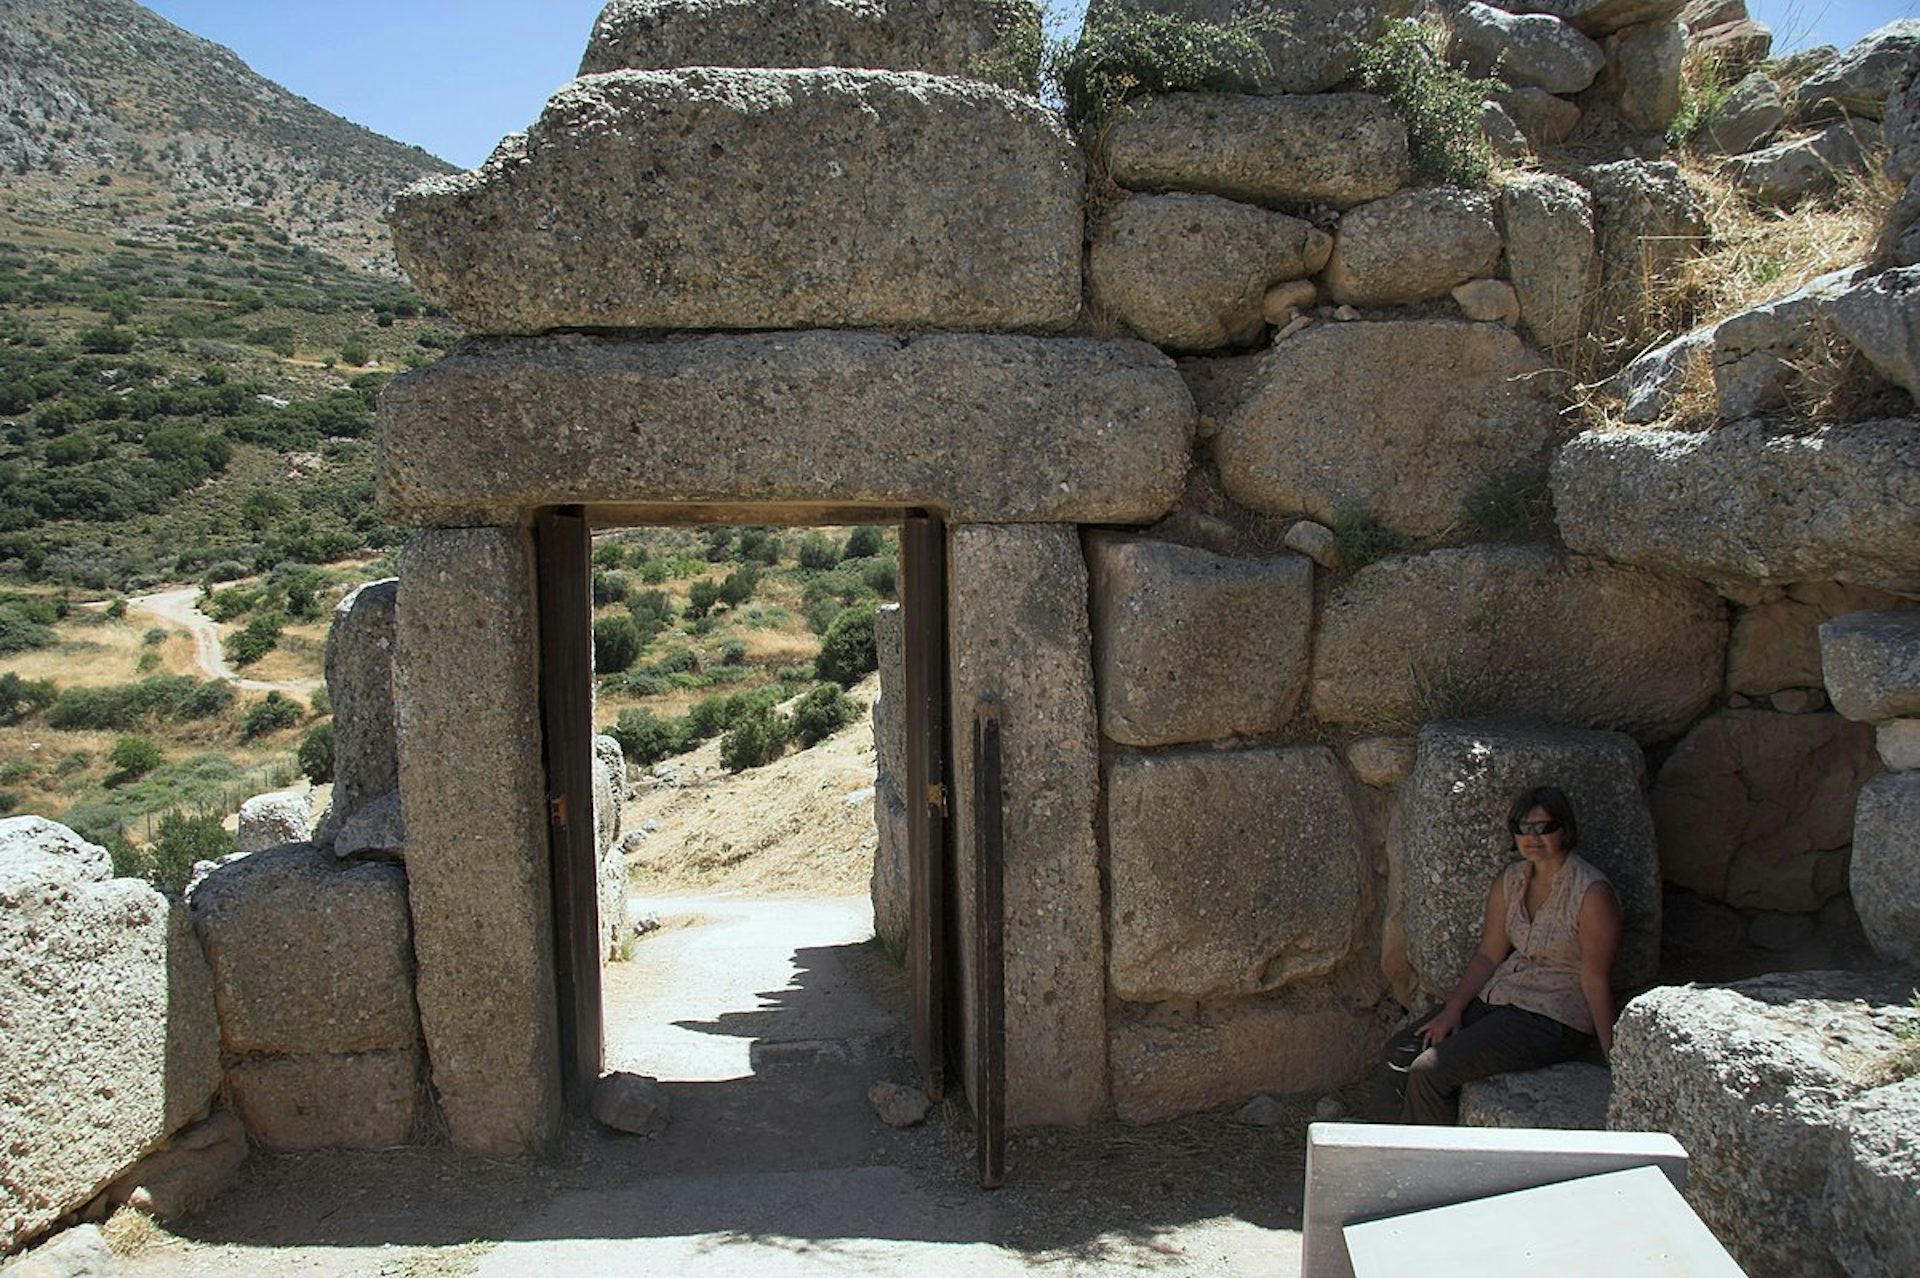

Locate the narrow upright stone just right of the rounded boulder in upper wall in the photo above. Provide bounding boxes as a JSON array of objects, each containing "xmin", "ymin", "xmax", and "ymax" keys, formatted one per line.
[{"xmin": 1500, "ymin": 173, "xmax": 1599, "ymax": 349}]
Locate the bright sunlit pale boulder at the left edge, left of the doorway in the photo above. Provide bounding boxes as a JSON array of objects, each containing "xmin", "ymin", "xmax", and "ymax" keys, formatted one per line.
[{"xmin": 0, "ymin": 817, "xmax": 221, "ymax": 1251}]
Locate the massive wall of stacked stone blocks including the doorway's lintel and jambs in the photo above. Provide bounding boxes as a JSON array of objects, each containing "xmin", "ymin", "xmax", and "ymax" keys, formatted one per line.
[{"xmin": 362, "ymin": 0, "xmax": 1920, "ymax": 1151}]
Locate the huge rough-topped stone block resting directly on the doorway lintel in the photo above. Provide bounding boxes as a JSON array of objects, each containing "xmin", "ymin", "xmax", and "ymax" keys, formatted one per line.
[{"xmin": 388, "ymin": 67, "xmax": 1081, "ymax": 334}]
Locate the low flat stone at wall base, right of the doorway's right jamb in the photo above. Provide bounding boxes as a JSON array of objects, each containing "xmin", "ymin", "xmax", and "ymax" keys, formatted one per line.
[{"xmin": 1112, "ymin": 996, "xmax": 1386, "ymax": 1123}]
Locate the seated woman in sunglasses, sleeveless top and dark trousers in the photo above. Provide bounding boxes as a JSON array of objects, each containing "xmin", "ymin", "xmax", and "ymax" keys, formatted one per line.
[{"xmin": 1386, "ymin": 785, "xmax": 1620, "ymax": 1123}]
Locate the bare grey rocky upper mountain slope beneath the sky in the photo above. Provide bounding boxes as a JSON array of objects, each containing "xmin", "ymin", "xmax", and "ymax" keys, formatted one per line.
[{"xmin": 0, "ymin": 0, "xmax": 451, "ymax": 274}]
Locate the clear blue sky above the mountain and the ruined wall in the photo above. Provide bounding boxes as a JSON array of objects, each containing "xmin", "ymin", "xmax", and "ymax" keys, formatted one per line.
[{"xmin": 146, "ymin": 0, "xmax": 1920, "ymax": 167}]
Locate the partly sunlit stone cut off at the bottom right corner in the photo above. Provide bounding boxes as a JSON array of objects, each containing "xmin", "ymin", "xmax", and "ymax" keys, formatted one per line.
[{"xmin": 1828, "ymin": 1078, "xmax": 1920, "ymax": 1278}]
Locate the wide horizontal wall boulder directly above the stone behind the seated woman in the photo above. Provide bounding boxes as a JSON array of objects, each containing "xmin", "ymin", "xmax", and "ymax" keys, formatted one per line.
[{"xmin": 1311, "ymin": 547, "xmax": 1726, "ymax": 741}]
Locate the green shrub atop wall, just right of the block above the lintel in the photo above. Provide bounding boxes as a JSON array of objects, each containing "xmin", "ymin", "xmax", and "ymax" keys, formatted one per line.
[{"xmin": 1041, "ymin": 4, "xmax": 1277, "ymax": 130}]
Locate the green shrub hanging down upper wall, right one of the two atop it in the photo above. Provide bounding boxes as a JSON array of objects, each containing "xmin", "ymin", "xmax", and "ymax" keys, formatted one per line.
[{"xmin": 1354, "ymin": 19, "xmax": 1505, "ymax": 186}]
